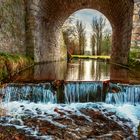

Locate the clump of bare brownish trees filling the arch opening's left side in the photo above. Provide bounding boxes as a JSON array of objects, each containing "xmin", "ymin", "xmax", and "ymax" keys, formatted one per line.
[{"xmin": 62, "ymin": 15, "xmax": 86, "ymax": 55}]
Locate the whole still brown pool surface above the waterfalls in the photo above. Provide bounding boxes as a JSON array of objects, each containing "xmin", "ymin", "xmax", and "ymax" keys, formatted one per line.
[{"xmin": 12, "ymin": 59, "xmax": 140, "ymax": 83}]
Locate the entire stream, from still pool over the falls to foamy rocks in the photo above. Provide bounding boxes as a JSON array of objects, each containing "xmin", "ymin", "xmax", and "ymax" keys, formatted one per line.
[{"xmin": 0, "ymin": 59, "xmax": 140, "ymax": 140}]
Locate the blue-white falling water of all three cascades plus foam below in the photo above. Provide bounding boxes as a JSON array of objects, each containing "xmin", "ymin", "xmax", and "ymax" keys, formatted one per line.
[{"xmin": 3, "ymin": 82, "xmax": 140, "ymax": 138}]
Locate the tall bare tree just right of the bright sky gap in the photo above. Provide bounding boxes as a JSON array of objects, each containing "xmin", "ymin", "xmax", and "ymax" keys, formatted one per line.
[{"xmin": 92, "ymin": 16, "xmax": 106, "ymax": 55}]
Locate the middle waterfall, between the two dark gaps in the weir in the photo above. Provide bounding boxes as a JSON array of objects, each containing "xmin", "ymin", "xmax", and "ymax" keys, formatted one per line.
[{"xmin": 65, "ymin": 82, "xmax": 103, "ymax": 103}]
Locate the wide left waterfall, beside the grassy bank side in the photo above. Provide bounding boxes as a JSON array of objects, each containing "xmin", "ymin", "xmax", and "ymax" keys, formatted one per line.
[{"xmin": 2, "ymin": 83, "xmax": 57, "ymax": 103}]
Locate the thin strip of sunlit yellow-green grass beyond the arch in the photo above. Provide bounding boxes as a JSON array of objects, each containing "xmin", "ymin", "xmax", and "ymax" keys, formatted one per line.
[{"xmin": 71, "ymin": 55, "xmax": 110, "ymax": 59}]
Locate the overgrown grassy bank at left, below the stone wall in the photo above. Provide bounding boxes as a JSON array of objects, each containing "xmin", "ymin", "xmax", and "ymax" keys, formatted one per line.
[{"xmin": 0, "ymin": 53, "xmax": 33, "ymax": 81}]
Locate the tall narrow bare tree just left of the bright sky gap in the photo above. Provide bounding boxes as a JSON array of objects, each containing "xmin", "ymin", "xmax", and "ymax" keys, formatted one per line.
[{"xmin": 76, "ymin": 20, "xmax": 86, "ymax": 55}]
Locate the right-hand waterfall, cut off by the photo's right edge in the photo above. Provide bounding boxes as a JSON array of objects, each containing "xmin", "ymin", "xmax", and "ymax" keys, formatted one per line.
[{"xmin": 106, "ymin": 84, "xmax": 140, "ymax": 105}]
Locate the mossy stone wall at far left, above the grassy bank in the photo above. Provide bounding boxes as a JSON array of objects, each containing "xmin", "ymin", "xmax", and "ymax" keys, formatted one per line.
[{"xmin": 0, "ymin": 0, "xmax": 26, "ymax": 54}]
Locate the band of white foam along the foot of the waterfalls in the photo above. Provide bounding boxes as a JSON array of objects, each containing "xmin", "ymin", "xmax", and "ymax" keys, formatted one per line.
[{"xmin": 4, "ymin": 101, "xmax": 140, "ymax": 127}]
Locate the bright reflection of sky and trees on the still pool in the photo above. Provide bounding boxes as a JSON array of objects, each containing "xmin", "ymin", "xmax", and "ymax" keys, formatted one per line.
[{"xmin": 66, "ymin": 59, "xmax": 110, "ymax": 81}]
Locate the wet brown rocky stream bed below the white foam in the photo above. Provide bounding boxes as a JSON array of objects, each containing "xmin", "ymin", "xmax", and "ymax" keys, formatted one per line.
[{"xmin": 0, "ymin": 108, "xmax": 134, "ymax": 140}]
